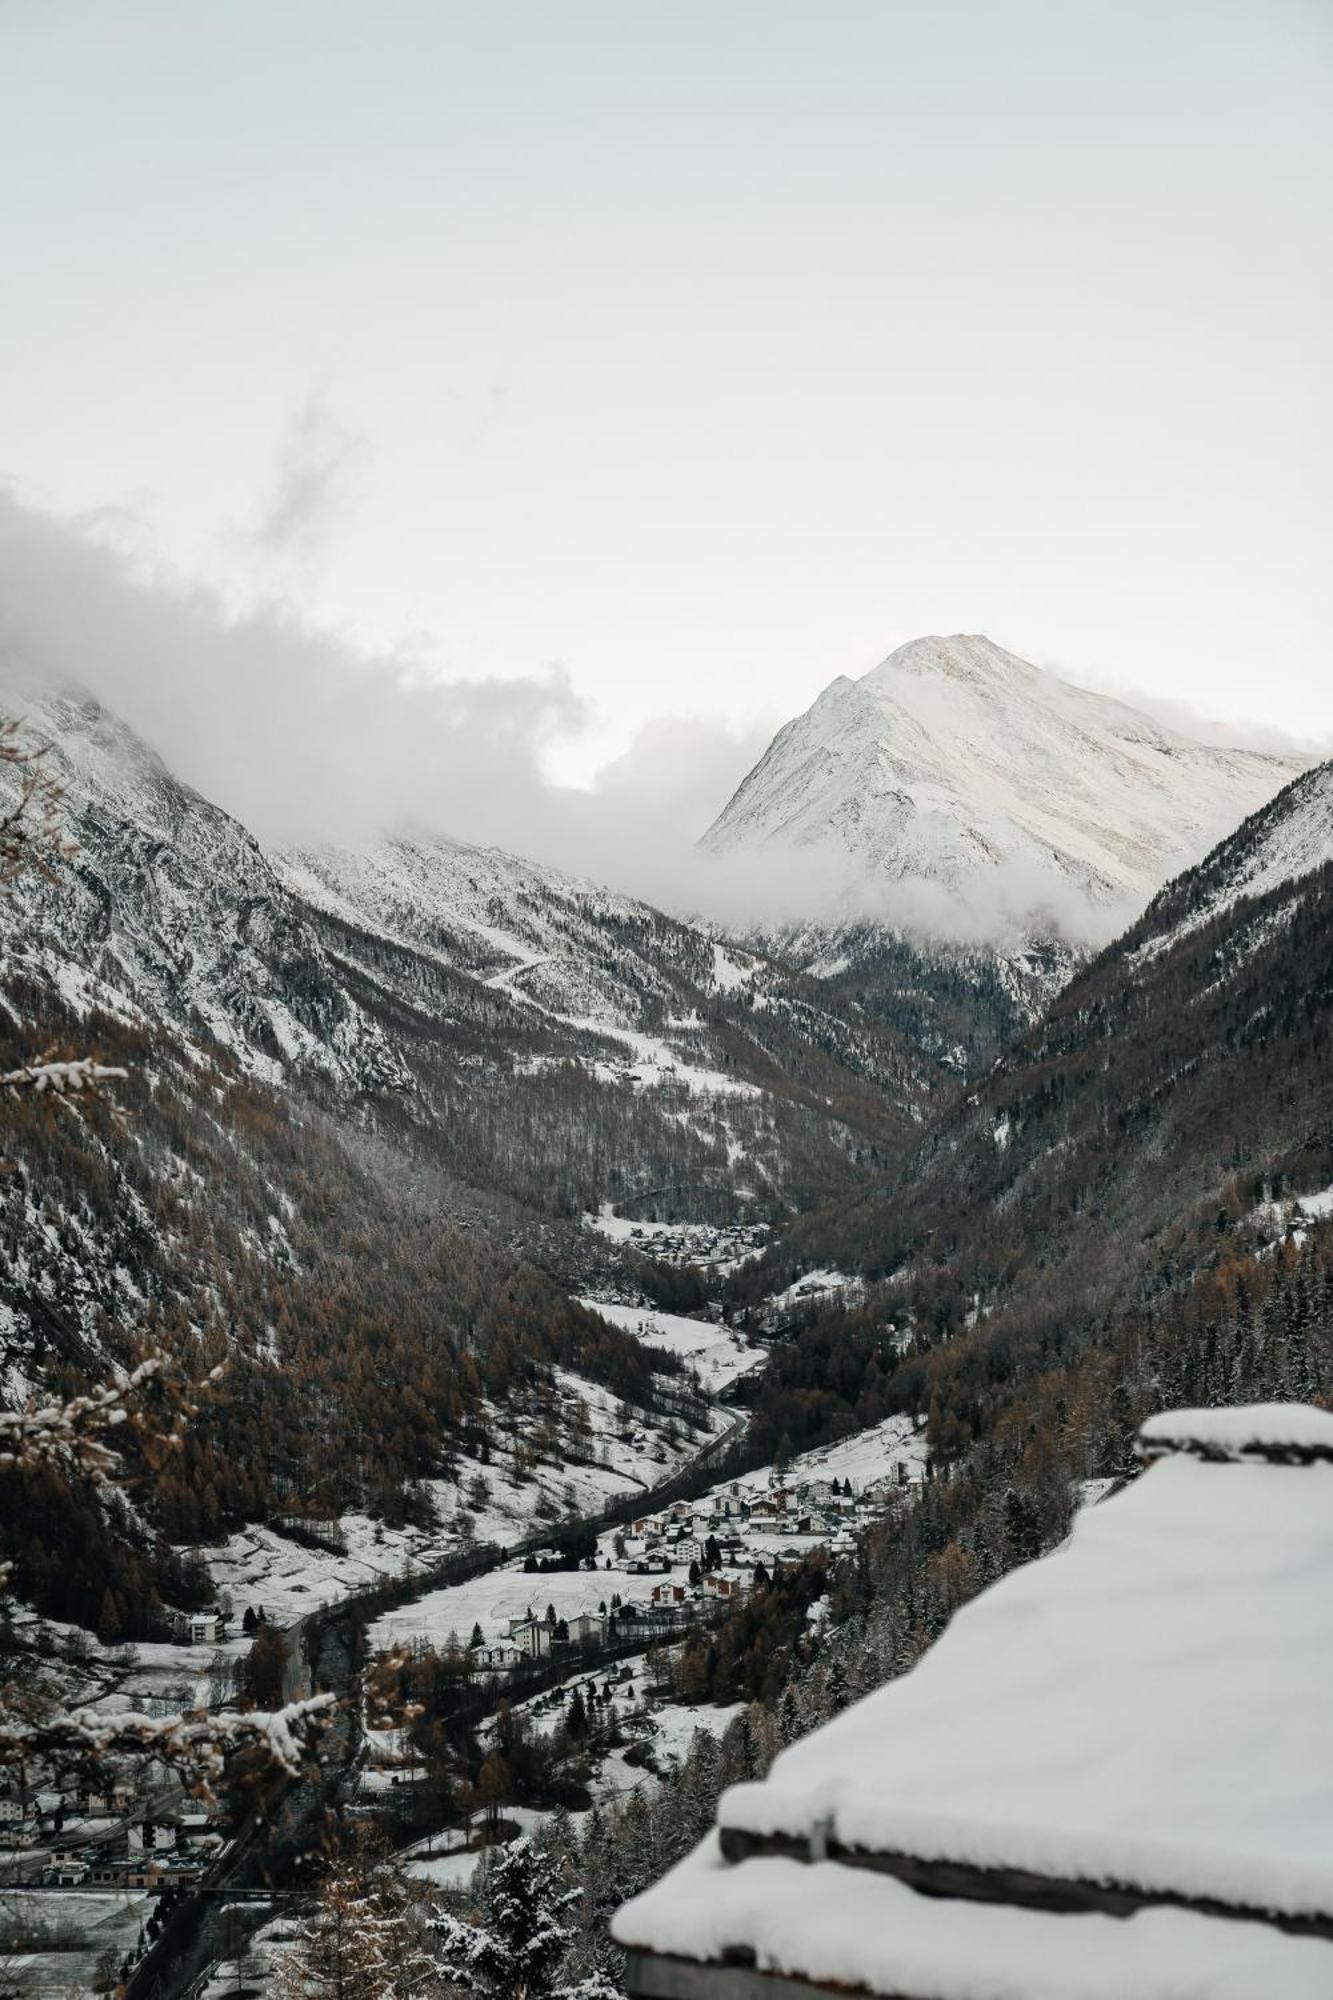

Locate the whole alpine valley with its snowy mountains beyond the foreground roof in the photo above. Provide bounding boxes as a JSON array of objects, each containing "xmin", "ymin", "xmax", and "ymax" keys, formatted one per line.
[{"xmin": 0, "ymin": 638, "xmax": 1333, "ymax": 1996}]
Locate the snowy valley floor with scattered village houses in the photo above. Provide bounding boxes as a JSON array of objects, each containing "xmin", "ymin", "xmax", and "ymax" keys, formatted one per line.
[{"xmin": 0, "ymin": 1256, "xmax": 927, "ymax": 1978}]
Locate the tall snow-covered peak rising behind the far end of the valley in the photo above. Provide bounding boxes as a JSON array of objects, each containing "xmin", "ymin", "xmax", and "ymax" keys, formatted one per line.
[{"xmin": 703, "ymin": 634, "xmax": 1303, "ymax": 1076}]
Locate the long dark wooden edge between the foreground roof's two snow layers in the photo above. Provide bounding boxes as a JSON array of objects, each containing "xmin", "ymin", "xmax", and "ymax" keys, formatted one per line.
[{"xmin": 719, "ymin": 1826, "xmax": 1333, "ymax": 1942}]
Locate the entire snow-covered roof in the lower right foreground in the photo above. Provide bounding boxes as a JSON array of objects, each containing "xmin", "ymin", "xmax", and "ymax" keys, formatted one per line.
[{"xmin": 612, "ymin": 1404, "xmax": 1333, "ymax": 2000}]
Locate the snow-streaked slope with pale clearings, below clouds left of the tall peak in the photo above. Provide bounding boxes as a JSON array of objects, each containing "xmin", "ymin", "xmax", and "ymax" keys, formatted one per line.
[{"xmin": 276, "ymin": 832, "xmax": 931, "ymax": 1214}]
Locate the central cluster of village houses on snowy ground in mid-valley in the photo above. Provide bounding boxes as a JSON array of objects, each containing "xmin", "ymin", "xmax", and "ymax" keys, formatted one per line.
[{"xmin": 470, "ymin": 1458, "xmax": 921, "ymax": 1672}]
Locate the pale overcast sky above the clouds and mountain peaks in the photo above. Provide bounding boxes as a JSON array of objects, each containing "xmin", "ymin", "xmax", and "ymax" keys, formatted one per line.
[{"xmin": 0, "ymin": 0, "xmax": 1333, "ymax": 804}]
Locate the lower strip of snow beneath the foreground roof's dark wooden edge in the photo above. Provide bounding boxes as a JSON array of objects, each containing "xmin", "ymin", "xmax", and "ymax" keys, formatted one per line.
[{"xmin": 610, "ymin": 1836, "xmax": 1333, "ymax": 2000}]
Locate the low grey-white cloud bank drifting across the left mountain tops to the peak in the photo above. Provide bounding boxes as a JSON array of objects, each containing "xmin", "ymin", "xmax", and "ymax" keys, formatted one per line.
[{"xmin": 0, "ymin": 488, "xmax": 1304, "ymax": 942}]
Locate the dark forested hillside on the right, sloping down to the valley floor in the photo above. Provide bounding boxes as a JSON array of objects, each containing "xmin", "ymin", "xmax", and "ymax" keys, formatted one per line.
[{"xmin": 731, "ymin": 768, "xmax": 1333, "ymax": 1456}]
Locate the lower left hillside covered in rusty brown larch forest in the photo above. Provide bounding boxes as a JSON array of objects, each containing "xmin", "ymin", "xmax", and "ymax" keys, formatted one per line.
[{"xmin": 0, "ymin": 980, "xmax": 681, "ymax": 1638}]
